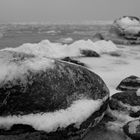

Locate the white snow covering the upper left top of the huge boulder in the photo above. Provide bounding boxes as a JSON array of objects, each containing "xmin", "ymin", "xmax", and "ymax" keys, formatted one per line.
[{"xmin": 0, "ymin": 51, "xmax": 54, "ymax": 86}]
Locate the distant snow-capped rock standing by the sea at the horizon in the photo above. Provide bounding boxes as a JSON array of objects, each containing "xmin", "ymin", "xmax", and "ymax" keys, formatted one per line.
[{"xmin": 110, "ymin": 16, "xmax": 140, "ymax": 44}]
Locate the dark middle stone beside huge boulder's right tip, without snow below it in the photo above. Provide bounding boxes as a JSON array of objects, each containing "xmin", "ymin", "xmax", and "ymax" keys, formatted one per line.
[{"xmin": 109, "ymin": 91, "xmax": 140, "ymax": 118}]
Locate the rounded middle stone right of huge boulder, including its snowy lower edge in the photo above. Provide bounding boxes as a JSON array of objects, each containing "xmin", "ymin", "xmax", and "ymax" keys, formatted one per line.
[{"xmin": 109, "ymin": 91, "xmax": 140, "ymax": 122}]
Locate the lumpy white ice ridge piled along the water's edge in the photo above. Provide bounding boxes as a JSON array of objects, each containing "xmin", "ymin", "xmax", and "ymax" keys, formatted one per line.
[{"xmin": 3, "ymin": 40, "xmax": 118, "ymax": 58}]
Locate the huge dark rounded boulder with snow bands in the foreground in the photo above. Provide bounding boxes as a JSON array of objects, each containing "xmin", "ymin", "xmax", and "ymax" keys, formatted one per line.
[{"xmin": 0, "ymin": 51, "xmax": 109, "ymax": 140}]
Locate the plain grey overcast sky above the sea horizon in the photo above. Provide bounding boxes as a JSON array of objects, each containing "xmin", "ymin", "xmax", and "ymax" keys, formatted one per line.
[{"xmin": 0, "ymin": 0, "xmax": 140, "ymax": 23}]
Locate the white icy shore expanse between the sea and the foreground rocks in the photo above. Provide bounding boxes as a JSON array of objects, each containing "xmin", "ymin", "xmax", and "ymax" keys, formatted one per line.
[{"xmin": 1, "ymin": 39, "xmax": 140, "ymax": 95}]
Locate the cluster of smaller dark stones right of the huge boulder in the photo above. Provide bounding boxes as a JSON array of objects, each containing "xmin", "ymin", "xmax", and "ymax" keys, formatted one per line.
[{"xmin": 109, "ymin": 76, "xmax": 140, "ymax": 140}]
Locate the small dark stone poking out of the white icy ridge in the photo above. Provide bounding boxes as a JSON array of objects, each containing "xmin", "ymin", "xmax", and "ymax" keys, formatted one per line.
[{"xmin": 80, "ymin": 50, "xmax": 100, "ymax": 57}]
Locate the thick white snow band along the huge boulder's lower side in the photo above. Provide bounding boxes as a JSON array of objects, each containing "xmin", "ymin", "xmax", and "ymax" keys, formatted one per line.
[{"xmin": 0, "ymin": 99, "xmax": 103, "ymax": 132}]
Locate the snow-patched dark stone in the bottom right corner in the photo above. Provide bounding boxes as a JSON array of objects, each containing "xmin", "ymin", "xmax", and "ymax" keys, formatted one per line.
[{"xmin": 123, "ymin": 120, "xmax": 140, "ymax": 140}]
